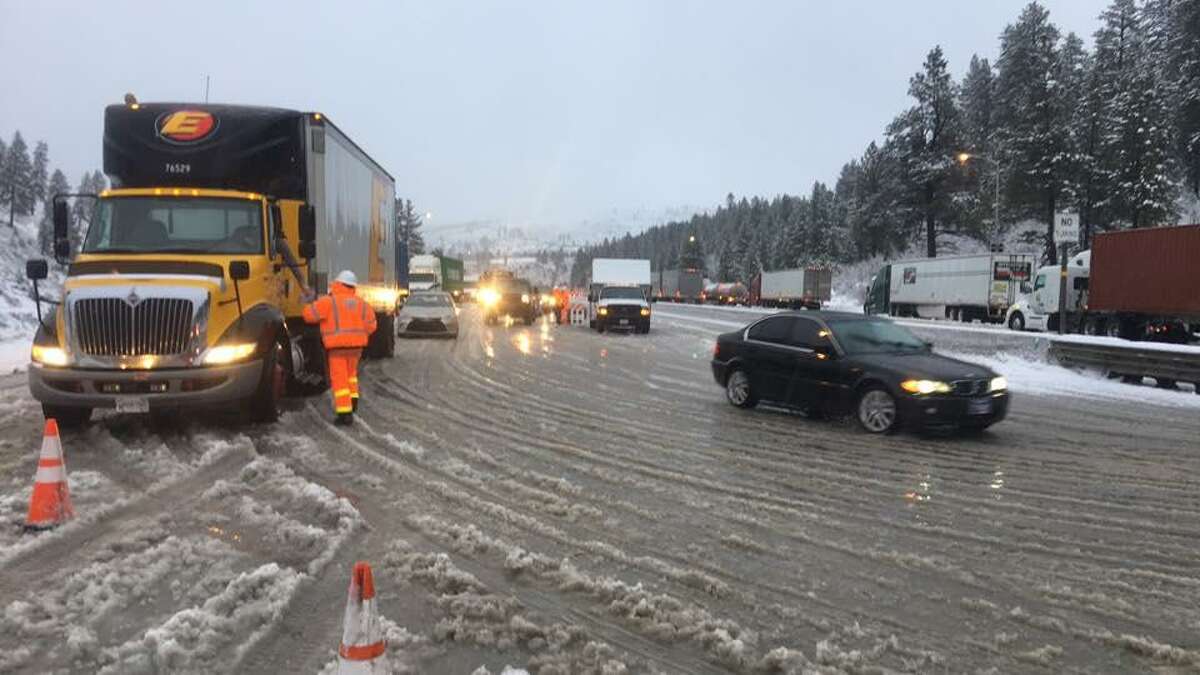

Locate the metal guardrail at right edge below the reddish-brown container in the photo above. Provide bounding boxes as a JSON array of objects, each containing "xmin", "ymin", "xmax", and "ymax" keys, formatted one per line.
[{"xmin": 1050, "ymin": 340, "xmax": 1200, "ymax": 384}]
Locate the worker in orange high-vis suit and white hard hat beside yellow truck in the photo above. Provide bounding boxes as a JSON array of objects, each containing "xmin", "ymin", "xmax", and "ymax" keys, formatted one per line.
[{"xmin": 304, "ymin": 270, "xmax": 376, "ymax": 424}]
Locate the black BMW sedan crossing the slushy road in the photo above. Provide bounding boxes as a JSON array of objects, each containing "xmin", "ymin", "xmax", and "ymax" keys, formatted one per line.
[{"xmin": 713, "ymin": 311, "xmax": 1009, "ymax": 434}]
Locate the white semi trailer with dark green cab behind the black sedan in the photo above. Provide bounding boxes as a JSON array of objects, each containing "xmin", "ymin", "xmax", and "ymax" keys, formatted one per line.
[{"xmin": 863, "ymin": 253, "xmax": 1034, "ymax": 323}]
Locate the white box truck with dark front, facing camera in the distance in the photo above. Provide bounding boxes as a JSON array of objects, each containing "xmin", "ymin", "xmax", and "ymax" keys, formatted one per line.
[{"xmin": 588, "ymin": 258, "xmax": 650, "ymax": 333}]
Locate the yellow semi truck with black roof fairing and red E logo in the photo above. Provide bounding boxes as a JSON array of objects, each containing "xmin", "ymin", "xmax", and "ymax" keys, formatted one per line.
[{"xmin": 26, "ymin": 102, "xmax": 402, "ymax": 426}]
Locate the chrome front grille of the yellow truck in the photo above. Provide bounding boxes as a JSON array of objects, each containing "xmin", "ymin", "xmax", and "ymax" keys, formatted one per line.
[{"xmin": 74, "ymin": 298, "xmax": 194, "ymax": 357}]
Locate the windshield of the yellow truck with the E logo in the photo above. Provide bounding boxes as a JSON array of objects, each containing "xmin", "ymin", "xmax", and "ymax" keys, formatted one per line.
[{"xmin": 83, "ymin": 197, "xmax": 264, "ymax": 253}]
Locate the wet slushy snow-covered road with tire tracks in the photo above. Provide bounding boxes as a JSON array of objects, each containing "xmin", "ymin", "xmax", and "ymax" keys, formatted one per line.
[{"xmin": 0, "ymin": 307, "xmax": 1200, "ymax": 674}]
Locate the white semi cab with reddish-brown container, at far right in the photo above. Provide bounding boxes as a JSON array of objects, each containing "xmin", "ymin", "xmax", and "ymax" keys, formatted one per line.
[{"xmin": 1008, "ymin": 225, "xmax": 1200, "ymax": 344}]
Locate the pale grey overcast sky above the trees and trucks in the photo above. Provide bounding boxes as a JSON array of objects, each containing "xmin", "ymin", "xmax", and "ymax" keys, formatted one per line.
[{"xmin": 0, "ymin": 0, "xmax": 1104, "ymax": 227}]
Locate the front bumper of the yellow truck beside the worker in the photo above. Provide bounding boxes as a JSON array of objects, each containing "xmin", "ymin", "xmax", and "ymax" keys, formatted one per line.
[{"xmin": 29, "ymin": 359, "xmax": 263, "ymax": 408}]
